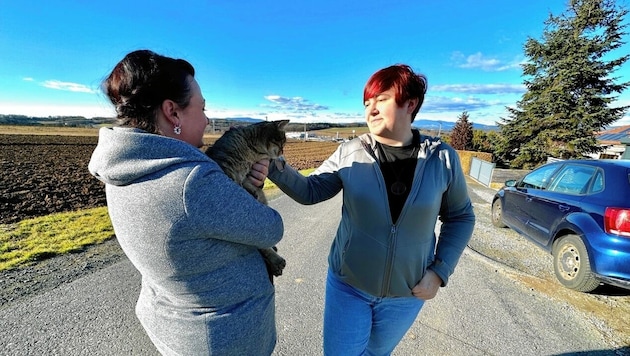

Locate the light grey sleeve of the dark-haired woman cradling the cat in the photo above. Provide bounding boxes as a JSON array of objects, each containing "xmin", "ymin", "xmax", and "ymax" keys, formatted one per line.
[{"xmin": 183, "ymin": 163, "xmax": 284, "ymax": 248}]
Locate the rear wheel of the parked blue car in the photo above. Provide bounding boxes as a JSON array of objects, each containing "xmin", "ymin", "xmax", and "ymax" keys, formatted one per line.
[{"xmin": 553, "ymin": 235, "xmax": 600, "ymax": 292}]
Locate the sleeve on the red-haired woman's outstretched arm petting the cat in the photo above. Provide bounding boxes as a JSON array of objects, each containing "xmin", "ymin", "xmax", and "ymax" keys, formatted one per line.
[{"xmin": 267, "ymin": 145, "xmax": 343, "ymax": 205}]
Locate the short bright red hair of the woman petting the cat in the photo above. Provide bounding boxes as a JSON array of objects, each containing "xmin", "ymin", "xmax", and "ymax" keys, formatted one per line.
[{"xmin": 363, "ymin": 64, "xmax": 427, "ymax": 122}]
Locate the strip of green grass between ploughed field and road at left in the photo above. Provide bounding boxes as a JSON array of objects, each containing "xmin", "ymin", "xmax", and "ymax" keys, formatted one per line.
[{"xmin": 0, "ymin": 207, "xmax": 114, "ymax": 271}]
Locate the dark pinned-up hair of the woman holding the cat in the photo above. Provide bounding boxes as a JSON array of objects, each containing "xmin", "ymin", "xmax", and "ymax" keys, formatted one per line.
[{"xmin": 102, "ymin": 50, "xmax": 195, "ymax": 133}]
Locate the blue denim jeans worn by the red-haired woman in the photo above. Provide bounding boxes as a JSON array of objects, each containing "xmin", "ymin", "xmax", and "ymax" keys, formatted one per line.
[{"xmin": 324, "ymin": 270, "xmax": 424, "ymax": 356}]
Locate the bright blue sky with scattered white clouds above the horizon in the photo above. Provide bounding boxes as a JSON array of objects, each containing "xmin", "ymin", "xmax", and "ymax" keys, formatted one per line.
[{"xmin": 0, "ymin": 0, "xmax": 630, "ymax": 125}]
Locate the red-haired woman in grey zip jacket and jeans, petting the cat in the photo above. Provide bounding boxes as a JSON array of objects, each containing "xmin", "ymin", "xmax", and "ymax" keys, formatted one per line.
[{"xmin": 255, "ymin": 65, "xmax": 475, "ymax": 355}]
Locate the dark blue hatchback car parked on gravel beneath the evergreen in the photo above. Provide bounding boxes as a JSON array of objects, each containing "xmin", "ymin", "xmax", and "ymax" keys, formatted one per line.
[{"xmin": 492, "ymin": 160, "xmax": 630, "ymax": 292}]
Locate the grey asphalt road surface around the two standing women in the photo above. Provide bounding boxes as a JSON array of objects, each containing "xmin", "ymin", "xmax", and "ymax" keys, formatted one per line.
[{"xmin": 0, "ymin": 182, "xmax": 616, "ymax": 356}]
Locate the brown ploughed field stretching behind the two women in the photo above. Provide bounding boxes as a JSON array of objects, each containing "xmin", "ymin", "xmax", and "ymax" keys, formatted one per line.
[{"xmin": 0, "ymin": 134, "xmax": 338, "ymax": 224}]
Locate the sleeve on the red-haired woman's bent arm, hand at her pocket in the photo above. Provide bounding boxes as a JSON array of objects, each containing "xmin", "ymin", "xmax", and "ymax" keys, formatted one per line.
[{"xmin": 429, "ymin": 145, "xmax": 475, "ymax": 287}]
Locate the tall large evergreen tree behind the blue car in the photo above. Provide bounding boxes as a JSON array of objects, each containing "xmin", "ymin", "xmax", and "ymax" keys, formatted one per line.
[{"xmin": 496, "ymin": 0, "xmax": 630, "ymax": 169}]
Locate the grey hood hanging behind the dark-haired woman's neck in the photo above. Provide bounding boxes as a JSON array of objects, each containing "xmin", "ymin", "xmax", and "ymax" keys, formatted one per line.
[{"xmin": 88, "ymin": 127, "xmax": 210, "ymax": 185}]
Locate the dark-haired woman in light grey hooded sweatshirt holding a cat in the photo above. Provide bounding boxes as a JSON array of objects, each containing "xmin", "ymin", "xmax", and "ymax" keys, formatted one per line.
[{"xmin": 89, "ymin": 50, "xmax": 283, "ymax": 355}]
